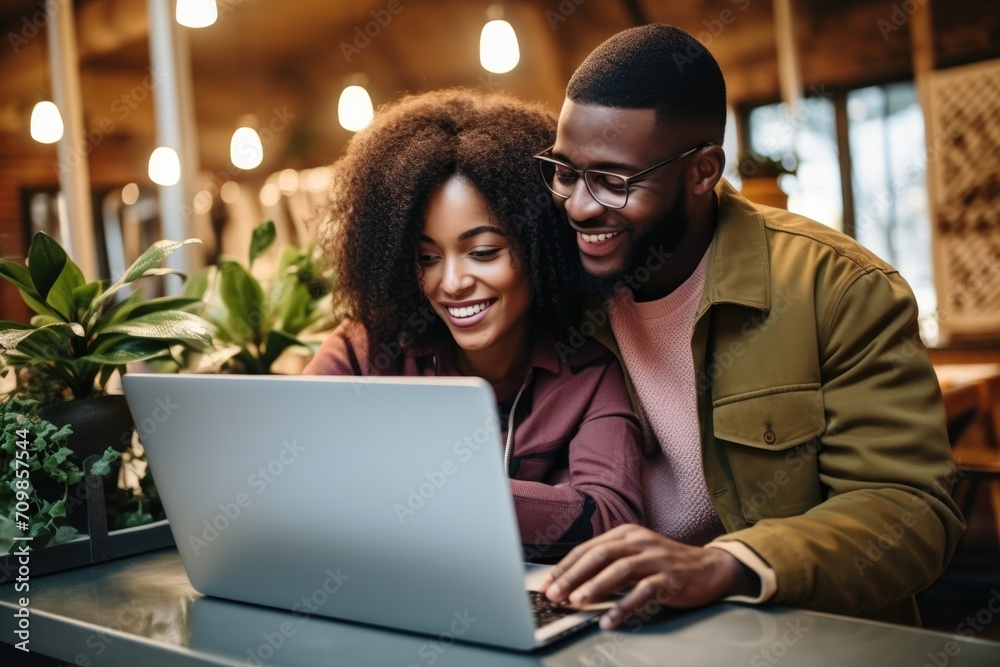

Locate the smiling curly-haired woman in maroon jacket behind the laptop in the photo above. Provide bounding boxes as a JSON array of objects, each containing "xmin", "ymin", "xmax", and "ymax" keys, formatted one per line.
[{"xmin": 304, "ymin": 91, "xmax": 642, "ymax": 560}]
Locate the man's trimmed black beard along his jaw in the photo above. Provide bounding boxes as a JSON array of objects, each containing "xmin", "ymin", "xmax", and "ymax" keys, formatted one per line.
[{"xmin": 577, "ymin": 183, "xmax": 688, "ymax": 299}]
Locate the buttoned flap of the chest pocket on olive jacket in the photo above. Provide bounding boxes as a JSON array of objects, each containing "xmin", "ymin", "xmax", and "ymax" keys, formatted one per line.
[{"xmin": 713, "ymin": 384, "xmax": 826, "ymax": 450}]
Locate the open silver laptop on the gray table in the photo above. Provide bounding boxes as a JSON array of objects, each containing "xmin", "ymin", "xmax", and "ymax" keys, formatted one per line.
[{"xmin": 123, "ymin": 374, "xmax": 600, "ymax": 650}]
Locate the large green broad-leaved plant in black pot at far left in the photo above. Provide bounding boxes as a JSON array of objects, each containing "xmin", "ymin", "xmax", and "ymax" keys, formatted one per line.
[{"xmin": 0, "ymin": 232, "xmax": 212, "ymax": 528}]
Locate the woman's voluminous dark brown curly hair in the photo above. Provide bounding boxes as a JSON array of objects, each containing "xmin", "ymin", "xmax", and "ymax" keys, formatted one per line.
[{"xmin": 316, "ymin": 89, "xmax": 581, "ymax": 345}]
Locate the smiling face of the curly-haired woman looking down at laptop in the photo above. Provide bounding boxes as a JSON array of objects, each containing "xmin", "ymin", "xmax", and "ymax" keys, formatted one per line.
[{"xmin": 417, "ymin": 175, "xmax": 533, "ymax": 352}]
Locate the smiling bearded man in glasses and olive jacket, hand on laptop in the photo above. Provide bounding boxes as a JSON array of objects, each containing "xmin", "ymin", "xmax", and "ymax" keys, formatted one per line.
[{"xmin": 538, "ymin": 25, "xmax": 965, "ymax": 628}]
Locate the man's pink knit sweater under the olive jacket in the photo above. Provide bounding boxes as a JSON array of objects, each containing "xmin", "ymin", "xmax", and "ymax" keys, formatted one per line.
[{"xmin": 610, "ymin": 252, "xmax": 723, "ymax": 545}]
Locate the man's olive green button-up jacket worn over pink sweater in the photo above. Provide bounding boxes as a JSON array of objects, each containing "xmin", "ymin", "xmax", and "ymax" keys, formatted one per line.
[{"xmin": 596, "ymin": 181, "xmax": 965, "ymax": 623}]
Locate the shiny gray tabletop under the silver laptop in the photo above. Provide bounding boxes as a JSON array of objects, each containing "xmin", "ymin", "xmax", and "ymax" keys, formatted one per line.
[{"xmin": 0, "ymin": 549, "xmax": 1000, "ymax": 667}]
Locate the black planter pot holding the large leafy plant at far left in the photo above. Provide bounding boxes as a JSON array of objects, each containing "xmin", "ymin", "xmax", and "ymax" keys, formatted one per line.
[{"xmin": 36, "ymin": 395, "xmax": 134, "ymax": 532}]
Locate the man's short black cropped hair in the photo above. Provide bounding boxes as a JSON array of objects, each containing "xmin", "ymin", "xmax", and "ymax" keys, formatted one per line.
[{"xmin": 566, "ymin": 23, "xmax": 726, "ymax": 143}]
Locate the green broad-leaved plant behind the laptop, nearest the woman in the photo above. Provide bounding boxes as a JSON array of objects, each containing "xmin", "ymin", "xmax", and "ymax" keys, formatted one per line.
[{"xmin": 182, "ymin": 220, "xmax": 336, "ymax": 374}]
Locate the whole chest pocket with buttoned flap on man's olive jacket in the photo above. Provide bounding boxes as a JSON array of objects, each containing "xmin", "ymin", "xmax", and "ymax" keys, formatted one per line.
[{"xmin": 712, "ymin": 384, "xmax": 826, "ymax": 523}]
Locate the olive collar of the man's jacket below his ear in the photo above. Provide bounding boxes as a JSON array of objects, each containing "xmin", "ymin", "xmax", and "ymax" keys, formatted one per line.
[{"xmin": 698, "ymin": 179, "xmax": 771, "ymax": 317}]
